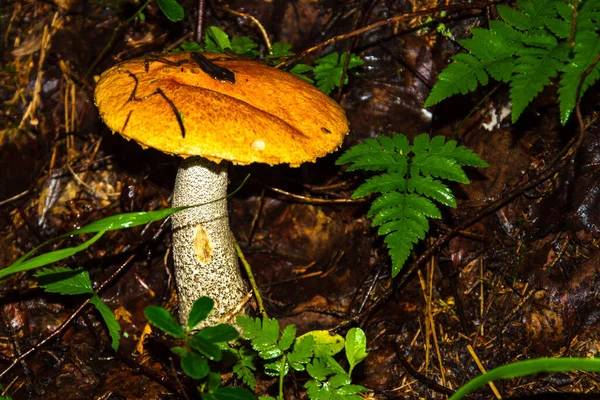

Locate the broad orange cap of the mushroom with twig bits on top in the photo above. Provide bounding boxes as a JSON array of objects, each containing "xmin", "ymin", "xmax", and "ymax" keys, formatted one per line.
[{"xmin": 95, "ymin": 53, "xmax": 348, "ymax": 166}]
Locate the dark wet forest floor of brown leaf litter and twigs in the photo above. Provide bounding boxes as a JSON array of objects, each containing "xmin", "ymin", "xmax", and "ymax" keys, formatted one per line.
[{"xmin": 0, "ymin": 0, "xmax": 600, "ymax": 399}]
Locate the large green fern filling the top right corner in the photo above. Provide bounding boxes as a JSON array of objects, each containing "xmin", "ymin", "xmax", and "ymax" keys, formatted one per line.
[{"xmin": 425, "ymin": 0, "xmax": 600, "ymax": 124}]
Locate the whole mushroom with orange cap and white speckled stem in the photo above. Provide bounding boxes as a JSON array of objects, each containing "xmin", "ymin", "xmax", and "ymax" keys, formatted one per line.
[{"xmin": 95, "ymin": 53, "xmax": 348, "ymax": 324}]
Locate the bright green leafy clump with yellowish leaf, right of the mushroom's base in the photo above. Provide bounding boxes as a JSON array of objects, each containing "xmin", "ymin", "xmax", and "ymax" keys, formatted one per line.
[{"xmin": 234, "ymin": 317, "xmax": 367, "ymax": 400}]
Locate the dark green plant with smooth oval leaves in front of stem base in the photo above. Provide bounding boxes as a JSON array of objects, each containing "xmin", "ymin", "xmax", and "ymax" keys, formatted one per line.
[{"xmin": 144, "ymin": 297, "xmax": 254, "ymax": 400}]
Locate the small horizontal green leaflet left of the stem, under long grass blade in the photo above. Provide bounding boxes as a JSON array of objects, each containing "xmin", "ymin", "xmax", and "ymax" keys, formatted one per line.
[{"xmin": 34, "ymin": 267, "xmax": 94, "ymax": 294}]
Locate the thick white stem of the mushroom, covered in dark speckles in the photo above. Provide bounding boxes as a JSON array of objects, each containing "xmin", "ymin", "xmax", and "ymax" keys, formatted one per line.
[{"xmin": 173, "ymin": 157, "xmax": 245, "ymax": 326}]
